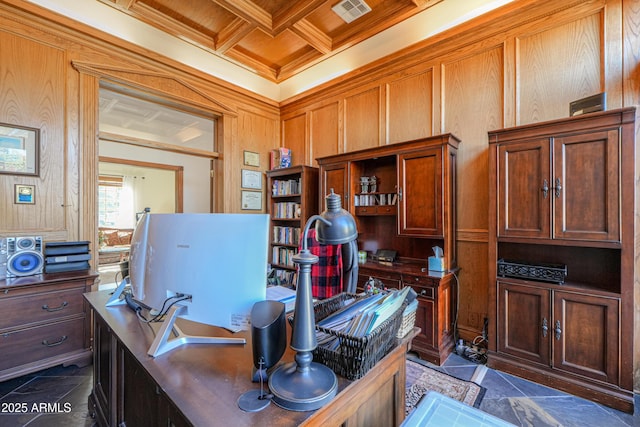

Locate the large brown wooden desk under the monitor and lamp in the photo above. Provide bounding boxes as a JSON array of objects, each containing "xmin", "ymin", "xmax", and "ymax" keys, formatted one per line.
[{"xmin": 85, "ymin": 291, "xmax": 414, "ymax": 427}]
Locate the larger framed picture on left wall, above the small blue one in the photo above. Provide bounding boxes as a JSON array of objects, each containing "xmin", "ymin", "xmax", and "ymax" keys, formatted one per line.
[{"xmin": 0, "ymin": 123, "xmax": 40, "ymax": 176}]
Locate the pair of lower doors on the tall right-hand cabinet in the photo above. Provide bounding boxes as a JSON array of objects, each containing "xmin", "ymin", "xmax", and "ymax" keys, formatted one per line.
[{"xmin": 498, "ymin": 280, "xmax": 620, "ymax": 385}]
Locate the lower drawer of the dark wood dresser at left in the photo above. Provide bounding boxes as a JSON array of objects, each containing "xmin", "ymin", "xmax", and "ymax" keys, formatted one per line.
[{"xmin": 0, "ymin": 318, "xmax": 84, "ymax": 370}]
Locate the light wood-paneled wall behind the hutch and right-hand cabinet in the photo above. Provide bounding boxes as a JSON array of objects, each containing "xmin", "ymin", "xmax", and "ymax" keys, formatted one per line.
[{"xmin": 281, "ymin": 0, "xmax": 640, "ymax": 389}]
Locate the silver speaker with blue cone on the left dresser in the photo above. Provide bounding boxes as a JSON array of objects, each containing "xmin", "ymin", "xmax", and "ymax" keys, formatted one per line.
[{"xmin": 6, "ymin": 236, "xmax": 44, "ymax": 277}]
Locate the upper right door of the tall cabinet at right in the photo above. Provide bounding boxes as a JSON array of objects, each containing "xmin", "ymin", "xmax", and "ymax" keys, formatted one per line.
[{"xmin": 552, "ymin": 131, "xmax": 620, "ymax": 241}]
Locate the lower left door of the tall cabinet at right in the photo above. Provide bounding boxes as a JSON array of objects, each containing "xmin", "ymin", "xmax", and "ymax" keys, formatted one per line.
[{"xmin": 498, "ymin": 282, "xmax": 552, "ymax": 366}]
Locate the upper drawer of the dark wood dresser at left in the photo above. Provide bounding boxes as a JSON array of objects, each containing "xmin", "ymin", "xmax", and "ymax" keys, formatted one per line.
[{"xmin": 0, "ymin": 288, "xmax": 84, "ymax": 331}]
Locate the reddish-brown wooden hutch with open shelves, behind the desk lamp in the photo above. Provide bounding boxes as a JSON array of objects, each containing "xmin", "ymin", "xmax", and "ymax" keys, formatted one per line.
[{"xmin": 316, "ymin": 134, "xmax": 460, "ymax": 364}]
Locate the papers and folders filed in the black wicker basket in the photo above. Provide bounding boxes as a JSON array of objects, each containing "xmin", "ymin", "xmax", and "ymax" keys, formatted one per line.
[{"xmin": 316, "ymin": 286, "xmax": 411, "ymax": 350}]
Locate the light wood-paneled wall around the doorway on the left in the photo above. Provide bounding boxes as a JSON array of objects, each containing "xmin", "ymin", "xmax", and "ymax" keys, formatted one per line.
[{"xmin": 0, "ymin": 0, "xmax": 280, "ymax": 247}]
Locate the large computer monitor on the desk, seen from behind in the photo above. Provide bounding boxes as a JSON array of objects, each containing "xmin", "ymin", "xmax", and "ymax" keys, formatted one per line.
[{"xmin": 109, "ymin": 213, "xmax": 269, "ymax": 356}]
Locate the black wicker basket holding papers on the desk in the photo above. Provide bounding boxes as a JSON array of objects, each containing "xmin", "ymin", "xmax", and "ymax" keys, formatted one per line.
[{"xmin": 289, "ymin": 293, "xmax": 406, "ymax": 380}]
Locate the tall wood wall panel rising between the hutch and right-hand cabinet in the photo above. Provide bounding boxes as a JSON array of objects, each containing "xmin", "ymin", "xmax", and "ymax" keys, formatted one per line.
[{"xmin": 441, "ymin": 46, "xmax": 504, "ymax": 339}]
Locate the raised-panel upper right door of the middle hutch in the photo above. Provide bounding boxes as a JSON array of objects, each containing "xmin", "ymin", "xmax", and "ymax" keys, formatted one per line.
[{"xmin": 398, "ymin": 149, "xmax": 443, "ymax": 237}]
